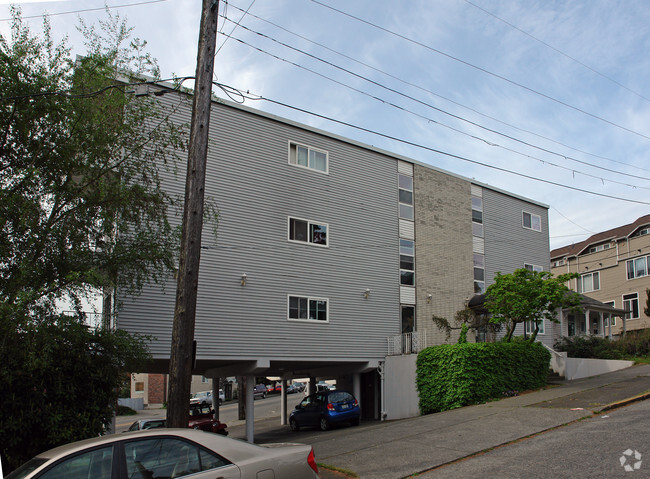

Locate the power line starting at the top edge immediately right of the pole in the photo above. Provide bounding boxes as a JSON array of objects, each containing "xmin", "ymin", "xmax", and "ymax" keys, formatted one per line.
[{"xmin": 225, "ymin": 1, "xmax": 650, "ymax": 173}]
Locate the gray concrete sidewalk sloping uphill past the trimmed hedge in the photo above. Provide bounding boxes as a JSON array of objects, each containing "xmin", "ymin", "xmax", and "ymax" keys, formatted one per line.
[{"xmin": 231, "ymin": 364, "xmax": 650, "ymax": 479}]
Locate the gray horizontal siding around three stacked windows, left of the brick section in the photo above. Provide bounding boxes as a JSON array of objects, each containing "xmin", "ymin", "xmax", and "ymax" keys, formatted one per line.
[{"xmin": 118, "ymin": 94, "xmax": 400, "ymax": 360}]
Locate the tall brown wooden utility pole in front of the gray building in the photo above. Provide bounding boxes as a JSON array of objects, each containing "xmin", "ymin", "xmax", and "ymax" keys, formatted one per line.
[{"xmin": 167, "ymin": 0, "xmax": 219, "ymax": 427}]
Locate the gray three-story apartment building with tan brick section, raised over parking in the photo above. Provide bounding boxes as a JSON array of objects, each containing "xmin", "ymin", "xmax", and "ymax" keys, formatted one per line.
[{"xmin": 117, "ymin": 81, "xmax": 550, "ymax": 428}]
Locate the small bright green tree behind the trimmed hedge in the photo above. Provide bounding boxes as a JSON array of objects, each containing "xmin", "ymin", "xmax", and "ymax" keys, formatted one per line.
[{"xmin": 485, "ymin": 268, "xmax": 582, "ymax": 342}]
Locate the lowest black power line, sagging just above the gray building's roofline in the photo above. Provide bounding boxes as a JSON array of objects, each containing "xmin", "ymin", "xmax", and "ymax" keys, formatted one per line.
[{"xmin": 219, "ymin": 85, "xmax": 650, "ymax": 205}]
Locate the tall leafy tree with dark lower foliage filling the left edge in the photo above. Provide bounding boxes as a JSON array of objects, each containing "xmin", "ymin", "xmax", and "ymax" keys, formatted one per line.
[{"xmin": 0, "ymin": 9, "xmax": 192, "ymax": 470}]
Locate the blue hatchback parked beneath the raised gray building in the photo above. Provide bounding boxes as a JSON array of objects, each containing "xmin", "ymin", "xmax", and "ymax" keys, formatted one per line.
[{"xmin": 289, "ymin": 390, "xmax": 361, "ymax": 431}]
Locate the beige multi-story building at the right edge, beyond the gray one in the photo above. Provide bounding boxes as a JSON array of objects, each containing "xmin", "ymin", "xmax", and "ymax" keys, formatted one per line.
[{"xmin": 551, "ymin": 215, "xmax": 650, "ymax": 336}]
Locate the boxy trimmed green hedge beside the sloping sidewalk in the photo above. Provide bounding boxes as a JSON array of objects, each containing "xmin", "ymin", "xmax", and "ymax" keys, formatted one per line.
[{"xmin": 416, "ymin": 342, "xmax": 551, "ymax": 414}]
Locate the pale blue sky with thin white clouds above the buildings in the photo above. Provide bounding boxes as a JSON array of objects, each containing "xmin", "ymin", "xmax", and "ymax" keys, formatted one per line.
[{"xmin": 5, "ymin": 0, "xmax": 650, "ymax": 253}]
